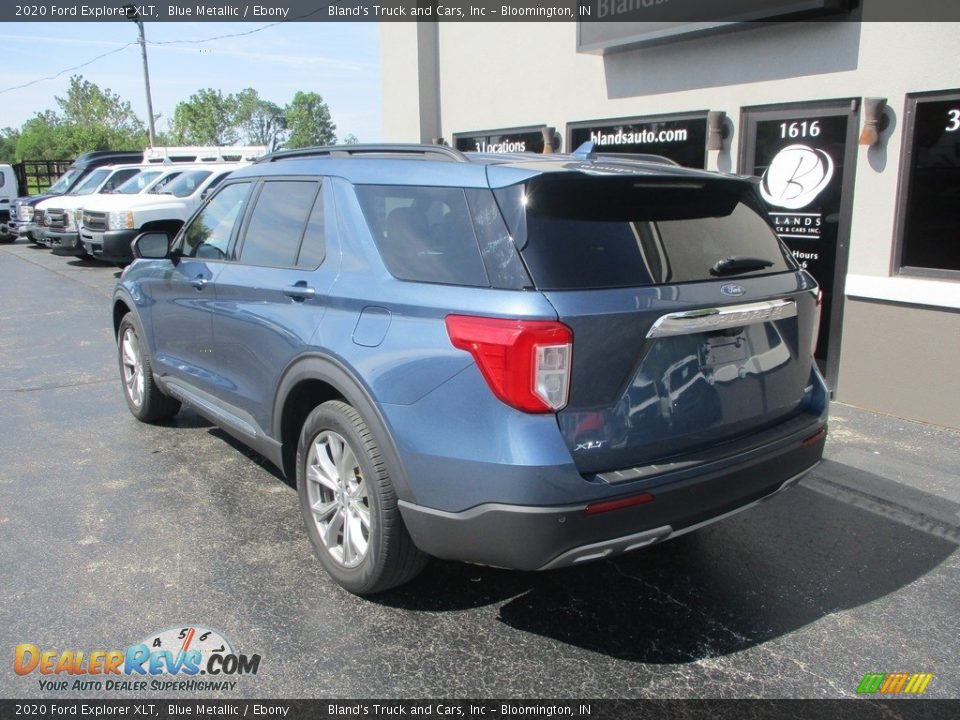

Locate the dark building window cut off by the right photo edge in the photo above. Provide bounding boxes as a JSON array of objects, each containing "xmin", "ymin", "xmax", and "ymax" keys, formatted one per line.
[{"xmin": 899, "ymin": 90, "xmax": 960, "ymax": 279}]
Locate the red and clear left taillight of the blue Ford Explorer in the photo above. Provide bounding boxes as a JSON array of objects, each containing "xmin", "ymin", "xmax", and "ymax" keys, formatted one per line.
[{"xmin": 447, "ymin": 315, "xmax": 573, "ymax": 413}]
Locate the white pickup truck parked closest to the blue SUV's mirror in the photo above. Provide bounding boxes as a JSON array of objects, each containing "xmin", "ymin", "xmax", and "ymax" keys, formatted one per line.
[{"xmin": 80, "ymin": 162, "xmax": 248, "ymax": 265}]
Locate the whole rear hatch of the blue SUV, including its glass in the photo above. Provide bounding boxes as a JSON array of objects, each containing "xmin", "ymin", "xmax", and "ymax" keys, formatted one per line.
[{"xmin": 494, "ymin": 170, "xmax": 817, "ymax": 481}]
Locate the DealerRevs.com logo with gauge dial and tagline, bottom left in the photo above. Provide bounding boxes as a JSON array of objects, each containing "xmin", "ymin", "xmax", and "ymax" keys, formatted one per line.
[{"xmin": 13, "ymin": 625, "xmax": 260, "ymax": 692}]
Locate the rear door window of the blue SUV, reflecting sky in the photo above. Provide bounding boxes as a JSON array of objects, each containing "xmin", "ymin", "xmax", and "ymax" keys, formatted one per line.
[{"xmin": 240, "ymin": 180, "xmax": 320, "ymax": 267}]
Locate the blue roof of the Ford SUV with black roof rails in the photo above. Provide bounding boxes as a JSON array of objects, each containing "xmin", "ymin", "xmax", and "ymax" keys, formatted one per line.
[{"xmin": 232, "ymin": 145, "xmax": 747, "ymax": 187}]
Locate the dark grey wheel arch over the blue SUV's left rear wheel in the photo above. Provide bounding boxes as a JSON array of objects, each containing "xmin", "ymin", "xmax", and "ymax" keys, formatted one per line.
[{"xmin": 271, "ymin": 353, "xmax": 416, "ymax": 502}]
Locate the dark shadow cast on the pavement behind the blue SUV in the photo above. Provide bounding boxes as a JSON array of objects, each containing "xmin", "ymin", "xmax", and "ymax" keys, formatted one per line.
[{"xmin": 373, "ymin": 471, "xmax": 957, "ymax": 663}]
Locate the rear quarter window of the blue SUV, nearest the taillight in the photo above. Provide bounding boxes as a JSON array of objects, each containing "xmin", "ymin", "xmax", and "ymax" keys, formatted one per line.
[{"xmin": 357, "ymin": 185, "xmax": 489, "ymax": 287}]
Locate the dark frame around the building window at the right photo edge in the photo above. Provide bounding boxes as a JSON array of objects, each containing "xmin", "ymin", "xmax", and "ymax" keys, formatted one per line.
[{"xmin": 890, "ymin": 88, "xmax": 960, "ymax": 281}]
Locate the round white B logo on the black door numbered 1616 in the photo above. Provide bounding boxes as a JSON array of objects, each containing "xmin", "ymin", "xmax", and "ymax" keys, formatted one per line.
[{"xmin": 760, "ymin": 145, "xmax": 833, "ymax": 210}]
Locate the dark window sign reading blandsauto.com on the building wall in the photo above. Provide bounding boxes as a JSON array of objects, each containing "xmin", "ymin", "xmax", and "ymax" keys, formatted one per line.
[{"xmin": 570, "ymin": 114, "xmax": 707, "ymax": 168}]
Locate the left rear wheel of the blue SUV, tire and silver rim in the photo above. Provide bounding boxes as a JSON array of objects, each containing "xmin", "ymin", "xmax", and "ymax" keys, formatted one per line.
[{"xmin": 297, "ymin": 401, "xmax": 427, "ymax": 595}]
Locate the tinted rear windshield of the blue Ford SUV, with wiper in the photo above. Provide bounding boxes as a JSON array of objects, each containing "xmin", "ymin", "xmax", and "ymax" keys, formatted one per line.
[{"xmin": 496, "ymin": 176, "xmax": 793, "ymax": 290}]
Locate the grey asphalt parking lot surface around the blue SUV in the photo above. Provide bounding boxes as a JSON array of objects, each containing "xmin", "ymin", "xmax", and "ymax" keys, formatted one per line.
[{"xmin": 0, "ymin": 242, "xmax": 960, "ymax": 698}]
